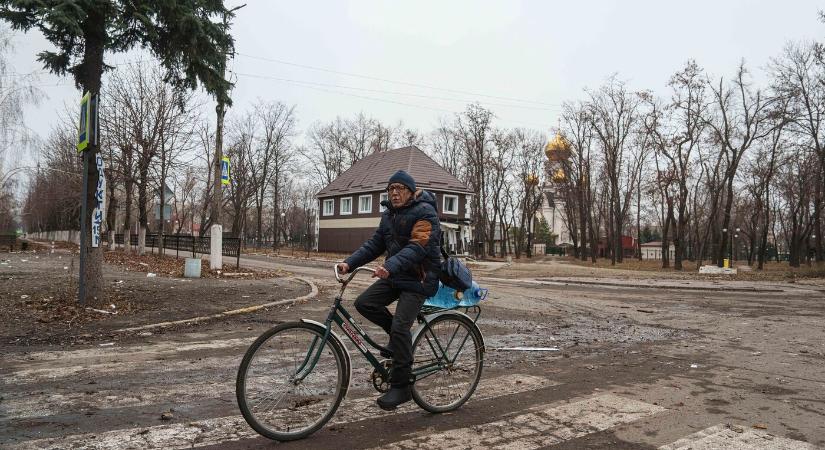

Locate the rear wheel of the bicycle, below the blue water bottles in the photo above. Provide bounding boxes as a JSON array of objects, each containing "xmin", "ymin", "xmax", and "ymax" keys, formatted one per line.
[{"xmin": 412, "ymin": 314, "xmax": 484, "ymax": 413}]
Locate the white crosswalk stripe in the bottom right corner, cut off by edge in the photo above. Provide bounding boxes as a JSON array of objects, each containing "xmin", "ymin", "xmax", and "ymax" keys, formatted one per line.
[{"xmin": 659, "ymin": 424, "xmax": 816, "ymax": 450}]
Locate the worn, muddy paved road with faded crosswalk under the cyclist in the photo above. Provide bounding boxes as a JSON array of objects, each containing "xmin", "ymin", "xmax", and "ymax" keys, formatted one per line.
[{"xmin": 0, "ymin": 258, "xmax": 825, "ymax": 449}]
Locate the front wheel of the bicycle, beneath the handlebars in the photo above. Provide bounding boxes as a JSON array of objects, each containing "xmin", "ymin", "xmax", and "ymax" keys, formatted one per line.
[{"xmin": 235, "ymin": 322, "xmax": 349, "ymax": 441}]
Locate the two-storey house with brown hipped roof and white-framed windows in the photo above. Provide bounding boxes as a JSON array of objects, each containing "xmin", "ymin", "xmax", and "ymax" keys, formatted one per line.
[{"xmin": 316, "ymin": 146, "xmax": 472, "ymax": 254}]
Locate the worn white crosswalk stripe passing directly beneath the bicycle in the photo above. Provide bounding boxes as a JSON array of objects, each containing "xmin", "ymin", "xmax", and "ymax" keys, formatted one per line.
[{"xmin": 8, "ymin": 375, "xmax": 556, "ymax": 449}]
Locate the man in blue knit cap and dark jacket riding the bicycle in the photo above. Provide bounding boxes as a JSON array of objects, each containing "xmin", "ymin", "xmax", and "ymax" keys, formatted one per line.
[{"xmin": 338, "ymin": 170, "xmax": 441, "ymax": 410}]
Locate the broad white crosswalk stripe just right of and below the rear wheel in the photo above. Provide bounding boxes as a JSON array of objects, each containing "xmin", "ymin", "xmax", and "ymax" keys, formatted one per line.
[{"xmin": 366, "ymin": 394, "xmax": 665, "ymax": 450}]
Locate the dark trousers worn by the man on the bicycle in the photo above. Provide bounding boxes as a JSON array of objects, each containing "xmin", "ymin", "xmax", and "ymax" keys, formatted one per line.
[{"xmin": 355, "ymin": 280, "xmax": 426, "ymax": 386}]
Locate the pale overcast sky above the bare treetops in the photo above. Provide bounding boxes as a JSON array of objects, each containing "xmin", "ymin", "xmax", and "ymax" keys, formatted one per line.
[{"xmin": 11, "ymin": 0, "xmax": 825, "ymax": 148}]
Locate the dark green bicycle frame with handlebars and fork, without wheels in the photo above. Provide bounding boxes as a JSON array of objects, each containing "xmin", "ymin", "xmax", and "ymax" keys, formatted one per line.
[{"xmin": 293, "ymin": 264, "xmax": 469, "ymax": 383}]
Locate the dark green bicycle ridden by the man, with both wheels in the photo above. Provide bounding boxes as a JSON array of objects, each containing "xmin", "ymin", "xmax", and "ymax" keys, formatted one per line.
[{"xmin": 235, "ymin": 265, "xmax": 485, "ymax": 441}]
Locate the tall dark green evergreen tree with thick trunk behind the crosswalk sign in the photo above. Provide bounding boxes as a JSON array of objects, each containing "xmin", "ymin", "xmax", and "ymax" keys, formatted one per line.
[{"xmin": 0, "ymin": 0, "xmax": 234, "ymax": 304}]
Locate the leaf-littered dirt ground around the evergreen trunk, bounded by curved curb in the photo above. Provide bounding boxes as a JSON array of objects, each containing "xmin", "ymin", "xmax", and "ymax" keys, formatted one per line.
[{"xmin": 0, "ymin": 245, "xmax": 310, "ymax": 345}]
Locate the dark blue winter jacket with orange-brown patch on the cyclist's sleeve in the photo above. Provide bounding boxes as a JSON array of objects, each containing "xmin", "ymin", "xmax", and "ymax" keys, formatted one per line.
[{"xmin": 344, "ymin": 190, "xmax": 441, "ymax": 297}]
